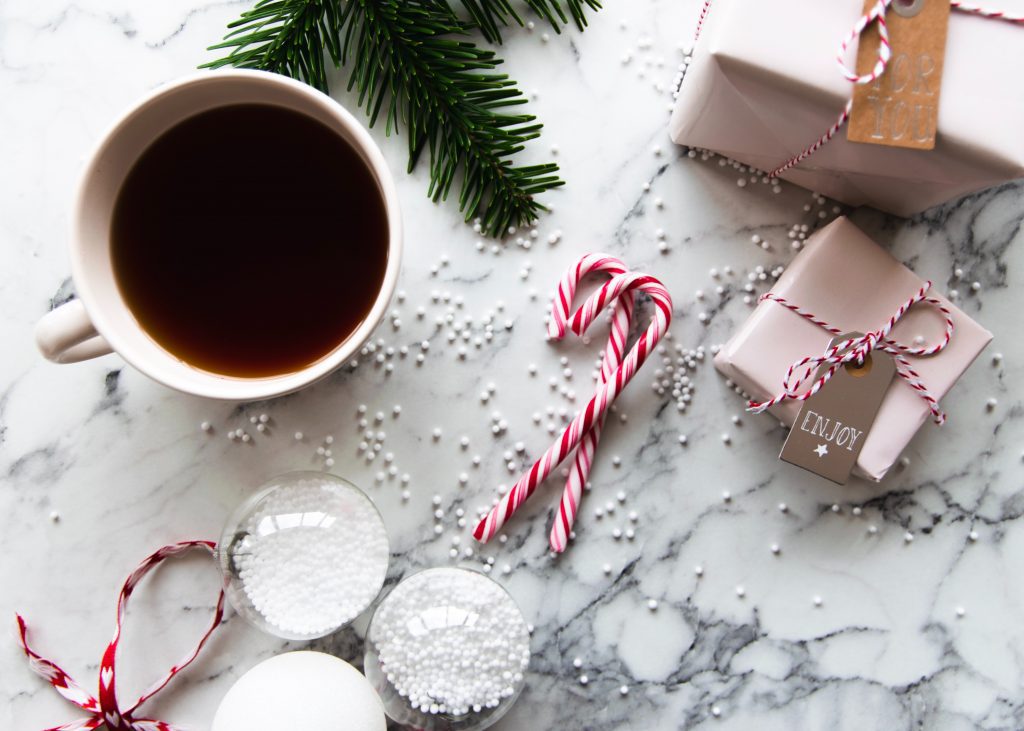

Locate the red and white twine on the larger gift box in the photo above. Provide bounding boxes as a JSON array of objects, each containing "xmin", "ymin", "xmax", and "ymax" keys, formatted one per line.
[{"xmin": 694, "ymin": 0, "xmax": 1024, "ymax": 178}]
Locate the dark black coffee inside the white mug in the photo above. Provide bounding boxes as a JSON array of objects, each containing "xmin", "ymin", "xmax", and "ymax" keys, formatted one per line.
[{"xmin": 111, "ymin": 104, "xmax": 389, "ymax": 378}]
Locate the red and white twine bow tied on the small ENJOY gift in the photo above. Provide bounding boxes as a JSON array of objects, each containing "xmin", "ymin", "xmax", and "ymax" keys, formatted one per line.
[{"xmin": 748, "ymin": 282, "xmax": 953, "ymax": 424}]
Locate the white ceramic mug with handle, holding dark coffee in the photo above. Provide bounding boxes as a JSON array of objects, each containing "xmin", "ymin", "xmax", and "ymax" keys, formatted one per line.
[{"xmin": 36, "ymin": 70, "xmax": 401, "ymax": 400}]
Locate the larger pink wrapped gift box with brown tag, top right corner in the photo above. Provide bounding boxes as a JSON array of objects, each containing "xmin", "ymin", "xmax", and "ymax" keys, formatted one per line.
[{"xmin": 670, "ymin": 0, "xmax": 1024, "ymax": 216}]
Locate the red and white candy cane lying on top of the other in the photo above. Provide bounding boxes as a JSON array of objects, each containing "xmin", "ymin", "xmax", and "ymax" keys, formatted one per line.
[{"xmin": 473, "ymin": 273, "xmax": 672, "ymax": 543}]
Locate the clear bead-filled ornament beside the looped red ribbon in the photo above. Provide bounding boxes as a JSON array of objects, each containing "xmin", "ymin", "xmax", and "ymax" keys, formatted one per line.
[{"xmin": 218, "ymin": 472, "xmax": 389, "ymax": 640}]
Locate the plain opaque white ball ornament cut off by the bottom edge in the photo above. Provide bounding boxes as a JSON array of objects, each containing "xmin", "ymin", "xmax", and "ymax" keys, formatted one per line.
[{"xmin": 211, "ymin": 651, "xmax": 387, "ymax": 731}]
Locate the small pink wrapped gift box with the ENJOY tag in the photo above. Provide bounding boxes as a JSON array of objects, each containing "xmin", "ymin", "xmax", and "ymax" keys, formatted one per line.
[{"xmin": 715, "ymin": 218, "xmax": 992, "ymax": 481}]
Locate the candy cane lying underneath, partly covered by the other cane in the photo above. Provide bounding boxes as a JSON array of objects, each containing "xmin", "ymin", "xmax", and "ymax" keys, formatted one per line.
[{"xmin": 548, "ymin": 254, "xmax": 634, "ymax": 553}]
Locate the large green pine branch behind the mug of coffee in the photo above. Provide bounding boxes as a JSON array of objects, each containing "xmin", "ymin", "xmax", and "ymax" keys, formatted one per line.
[{"xmin": 204, "ymin": 0, "xmax": 562, "ymax": 235}]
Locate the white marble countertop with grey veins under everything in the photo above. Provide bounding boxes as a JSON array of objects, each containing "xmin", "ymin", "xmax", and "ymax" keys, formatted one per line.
[{"xmin": 6, "ymin": 0, "xmax": 1024, "ymax": 731}]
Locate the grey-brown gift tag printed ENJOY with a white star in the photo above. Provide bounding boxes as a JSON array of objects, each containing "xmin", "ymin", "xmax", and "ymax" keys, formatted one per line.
[{"xmin": 779, "ymin": 333, "xmax": 896, "ymax": 484}]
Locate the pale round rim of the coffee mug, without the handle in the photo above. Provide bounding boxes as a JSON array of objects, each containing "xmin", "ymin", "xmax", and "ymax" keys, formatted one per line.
[{"xmin": 70, "ymin": 69, "xmax": 402, "ymax": 401}]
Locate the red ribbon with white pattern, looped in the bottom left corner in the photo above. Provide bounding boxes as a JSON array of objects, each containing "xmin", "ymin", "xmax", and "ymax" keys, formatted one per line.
[{"xmin": 16, "ymin": 541, "xmax": 224, "ymax": 731}]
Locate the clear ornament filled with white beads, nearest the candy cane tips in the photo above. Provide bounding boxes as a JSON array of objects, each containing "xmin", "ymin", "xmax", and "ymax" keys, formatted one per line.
[{"xmin": 364, "ymin": 568, "xmax": 529, "ymax": 731}]
